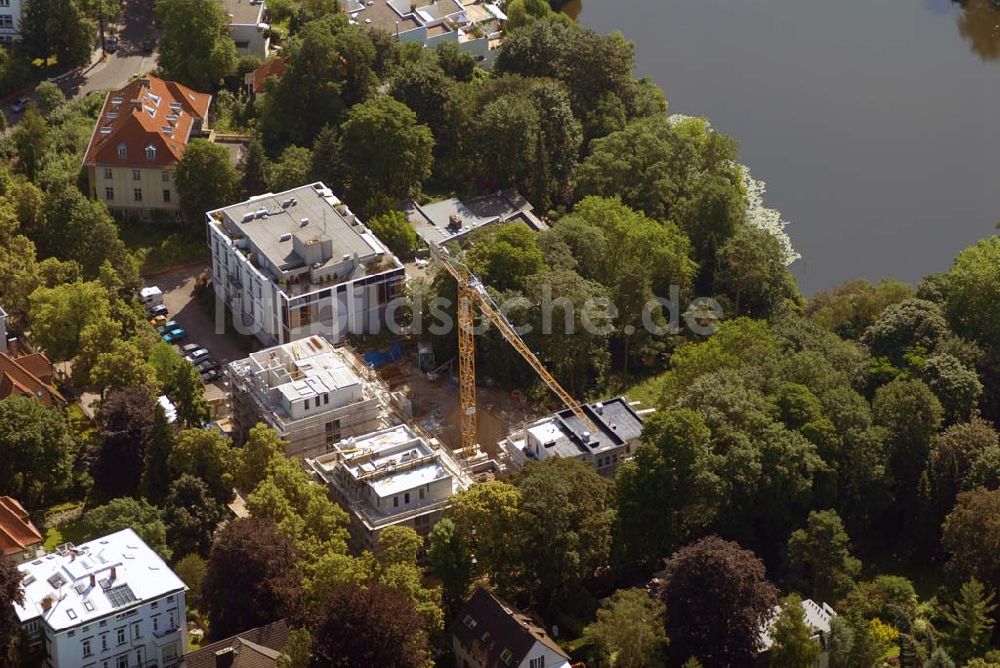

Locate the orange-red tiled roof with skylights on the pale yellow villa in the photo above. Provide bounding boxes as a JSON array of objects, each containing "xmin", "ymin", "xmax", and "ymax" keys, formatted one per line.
[{"xmin": 84, "ymin": 77, "xmax": 212, "ymax": 167}]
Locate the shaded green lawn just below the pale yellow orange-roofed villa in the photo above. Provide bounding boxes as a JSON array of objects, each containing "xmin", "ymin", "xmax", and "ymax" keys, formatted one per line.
[{"xmin": 120, "ymin": 221, "xmax": 210, "ymax": 274}]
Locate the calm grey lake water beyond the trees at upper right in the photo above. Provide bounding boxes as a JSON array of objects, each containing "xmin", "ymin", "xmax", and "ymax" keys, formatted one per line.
[{"xmin": 577, "ymin": 0, "xmax": 1000, "ymax": 295}]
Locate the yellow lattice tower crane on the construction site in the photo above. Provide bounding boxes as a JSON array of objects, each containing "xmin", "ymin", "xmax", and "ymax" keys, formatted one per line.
[{"xmin": 428, "ymin": 243, "xmax": 598, "ymax": 457}]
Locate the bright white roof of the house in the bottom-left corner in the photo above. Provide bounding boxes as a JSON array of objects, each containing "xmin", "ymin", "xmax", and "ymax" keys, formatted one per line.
[{"xmin": 14, "ymin": 529, "xmax": 187, "ymax": 631}]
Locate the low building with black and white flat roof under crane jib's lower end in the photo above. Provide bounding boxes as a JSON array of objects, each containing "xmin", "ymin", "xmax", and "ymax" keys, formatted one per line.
[{"xmin": 499, "ymin": 397, "xmax": 643, "ymax": 477}]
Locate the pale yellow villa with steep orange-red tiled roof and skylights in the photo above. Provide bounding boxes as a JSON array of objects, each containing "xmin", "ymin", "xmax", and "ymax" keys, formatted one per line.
[{"xmin": 82, "ymin": 76, "xmax": 212, "ymax": 218}]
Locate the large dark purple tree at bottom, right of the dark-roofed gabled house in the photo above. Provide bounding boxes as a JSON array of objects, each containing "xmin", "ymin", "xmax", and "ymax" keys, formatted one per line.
[{"xmin": 662, "ymin": 536, "xmax": 778, "ymax": 667}]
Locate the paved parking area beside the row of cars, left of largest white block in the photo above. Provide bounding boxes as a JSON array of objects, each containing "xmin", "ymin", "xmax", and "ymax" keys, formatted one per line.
[{"xmin": 146, "ymin": 264, "xmax": 251, "ymax": 401}]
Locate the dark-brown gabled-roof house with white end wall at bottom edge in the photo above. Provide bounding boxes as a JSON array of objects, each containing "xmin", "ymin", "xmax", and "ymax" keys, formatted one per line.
[{"xmin": 450, "ymin": 587, "xmax": 570, "ymax": 668}]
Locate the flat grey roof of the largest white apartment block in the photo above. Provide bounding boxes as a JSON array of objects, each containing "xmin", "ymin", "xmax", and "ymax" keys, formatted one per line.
[{"xmin": 209, "ymin": 182, "xmax": 386, "ymax": 280}]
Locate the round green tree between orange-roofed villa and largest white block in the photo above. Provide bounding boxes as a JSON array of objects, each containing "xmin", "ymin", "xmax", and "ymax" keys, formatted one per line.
[{"xmin": 174, "ymin": 138, "xmax": 239, "ymax": 225}]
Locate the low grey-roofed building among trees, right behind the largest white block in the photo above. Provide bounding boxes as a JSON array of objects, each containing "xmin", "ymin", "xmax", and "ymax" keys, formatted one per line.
[{"xmin": 403, "ymin": 188, "xmax": 548, "ymax": 246}]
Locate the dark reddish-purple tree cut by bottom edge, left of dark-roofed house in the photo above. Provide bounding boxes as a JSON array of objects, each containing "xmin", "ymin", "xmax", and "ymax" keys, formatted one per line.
[{"xmin": 309, "ymin": 583, "xmax": 429, "ymax": 668}]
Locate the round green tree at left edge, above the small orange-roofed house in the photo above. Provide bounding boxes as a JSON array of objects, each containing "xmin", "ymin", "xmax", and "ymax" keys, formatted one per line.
[{"xmin": 0, "ymin": 396, "xmax": 76, "ymax": 508}]
